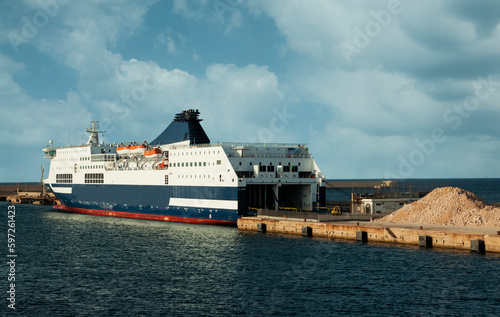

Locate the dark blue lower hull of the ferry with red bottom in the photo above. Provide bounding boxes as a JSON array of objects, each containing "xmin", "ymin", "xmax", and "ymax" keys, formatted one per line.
[{"xmin": 52, "ymin": 184, "xmax": 242, "ymax": 224}]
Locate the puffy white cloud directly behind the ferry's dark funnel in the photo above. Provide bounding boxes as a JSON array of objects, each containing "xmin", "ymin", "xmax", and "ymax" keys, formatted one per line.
[{"xmin": 94, "ymin": 61, "xmax": 282, "ymax": 141}]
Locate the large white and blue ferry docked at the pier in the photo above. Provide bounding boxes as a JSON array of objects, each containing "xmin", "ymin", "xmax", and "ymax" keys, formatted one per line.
[{"xmin": 43, "ymin": 109, "xmax": 325, "ymax": 225}]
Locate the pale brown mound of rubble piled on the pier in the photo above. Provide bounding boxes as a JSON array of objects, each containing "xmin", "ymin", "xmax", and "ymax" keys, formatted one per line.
[{"xmin": 378, "ymin": 187, "xmax": 500, "ymax": 228}]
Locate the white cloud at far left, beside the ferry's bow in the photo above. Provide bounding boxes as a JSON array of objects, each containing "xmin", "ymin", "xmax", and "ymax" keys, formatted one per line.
[{"xmin": 0, "ymin": 55, "xmax": 91, "ymax": 181}]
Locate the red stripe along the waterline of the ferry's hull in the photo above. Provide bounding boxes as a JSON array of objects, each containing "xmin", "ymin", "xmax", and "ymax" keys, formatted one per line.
[{"xmin": 54, "ymin": 205, "xmax": 236, "ymax": 225}]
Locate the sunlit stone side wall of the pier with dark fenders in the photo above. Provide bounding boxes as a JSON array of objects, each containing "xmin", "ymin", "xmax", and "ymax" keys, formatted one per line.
[{"xmin": 238, "ymin": 217, "xmax": 500, "ymax": 253}]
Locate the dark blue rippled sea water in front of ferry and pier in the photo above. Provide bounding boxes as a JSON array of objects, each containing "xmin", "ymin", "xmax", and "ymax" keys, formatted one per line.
[{"xmin": 0, "ymin": 178, "xmax": 500, "ymax": 316}]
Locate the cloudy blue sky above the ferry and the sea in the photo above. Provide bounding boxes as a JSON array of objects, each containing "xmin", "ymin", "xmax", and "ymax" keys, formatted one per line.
[{"xmin": 0, "ymin": 0, "xmax": 500, "ymax": 182}]
